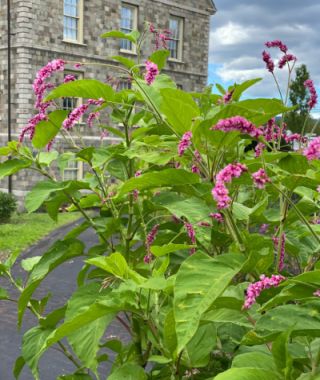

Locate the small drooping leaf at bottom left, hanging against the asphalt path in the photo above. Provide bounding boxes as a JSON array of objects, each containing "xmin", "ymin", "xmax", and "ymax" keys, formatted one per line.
[{"xmin": 22, "ymin": 327, "xmax": 52, "ymax": 380}]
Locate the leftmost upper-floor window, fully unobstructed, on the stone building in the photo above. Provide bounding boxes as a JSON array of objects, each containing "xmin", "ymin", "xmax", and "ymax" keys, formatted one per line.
[{"xmin": 63, "ymin": 0, "xmax": 83, "ymax": 43}]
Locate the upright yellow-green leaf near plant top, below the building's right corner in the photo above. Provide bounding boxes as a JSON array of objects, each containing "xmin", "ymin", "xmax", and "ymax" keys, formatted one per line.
[{"xmin": 161, "ymin": 88, "xmax": 200, "ymax": 135}]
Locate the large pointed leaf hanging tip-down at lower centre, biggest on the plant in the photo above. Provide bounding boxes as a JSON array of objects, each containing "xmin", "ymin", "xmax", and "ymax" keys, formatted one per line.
[{"xmin": 174, "ymin": 253, "xmax": 244, "ymax": 352}]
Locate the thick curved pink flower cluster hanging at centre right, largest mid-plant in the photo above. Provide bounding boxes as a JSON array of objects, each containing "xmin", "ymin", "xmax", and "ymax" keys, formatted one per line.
[{"xmin": 212, "ymin": 163, "xmax": 248, "ymax": 210}]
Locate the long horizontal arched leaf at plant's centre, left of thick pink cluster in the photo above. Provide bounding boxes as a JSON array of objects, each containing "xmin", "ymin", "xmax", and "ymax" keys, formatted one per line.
[{"xmin": 119, "ymin": 169, "xmax": 200, "ymax": 196}]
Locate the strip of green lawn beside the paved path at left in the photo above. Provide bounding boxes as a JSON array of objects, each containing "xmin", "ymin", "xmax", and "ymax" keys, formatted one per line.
[{"xmin": 0, "ymin": 213, "xmax": 80, "ymax": 261}]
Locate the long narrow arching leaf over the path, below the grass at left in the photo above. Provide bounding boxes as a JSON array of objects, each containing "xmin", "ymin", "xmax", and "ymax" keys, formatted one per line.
[{"xmin": 18, "ymin": 240, "xmax": 84, "ymax": 326}]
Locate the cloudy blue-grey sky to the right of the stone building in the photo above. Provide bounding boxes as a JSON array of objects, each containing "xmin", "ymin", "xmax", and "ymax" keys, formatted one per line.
[{"xmin": 209, "ymin": 0, "xmax": 320, "ymax": 117}]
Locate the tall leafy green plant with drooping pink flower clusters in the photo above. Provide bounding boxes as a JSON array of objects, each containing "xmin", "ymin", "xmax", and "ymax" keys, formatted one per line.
[{"xmin": 0, "ymin": 26, "xmax": 320, "ymax": 380}]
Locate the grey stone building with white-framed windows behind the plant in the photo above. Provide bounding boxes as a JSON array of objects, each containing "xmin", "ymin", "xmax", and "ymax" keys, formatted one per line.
[{"xmin": 0, "ymin": 0, "xmax": 216, "ymax": 200}]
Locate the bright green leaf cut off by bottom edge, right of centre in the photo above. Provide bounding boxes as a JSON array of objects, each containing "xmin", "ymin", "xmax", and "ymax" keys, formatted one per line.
[{"xmin": 212, "ymin": 367, "xmax": 282, "ymax": 380}]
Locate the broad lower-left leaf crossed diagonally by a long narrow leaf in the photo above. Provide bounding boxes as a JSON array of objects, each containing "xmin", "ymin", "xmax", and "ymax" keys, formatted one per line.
[{"xmin": 65, "ymin": 282, "xmax": 113, "ymax": 373}]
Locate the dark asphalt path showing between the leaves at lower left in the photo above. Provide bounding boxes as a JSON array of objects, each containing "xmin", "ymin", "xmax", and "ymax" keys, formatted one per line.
[{"xmin": 0, "ymin": 220, "xmax": 123, "ymax": 380}]
